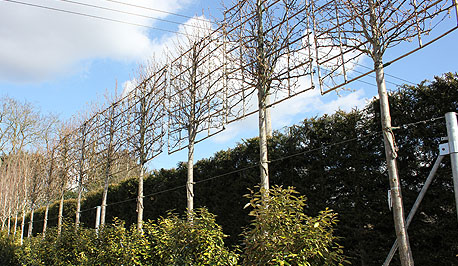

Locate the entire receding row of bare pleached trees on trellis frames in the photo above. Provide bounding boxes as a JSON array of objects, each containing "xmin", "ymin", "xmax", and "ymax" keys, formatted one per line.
[{"xmin": 1, "ymin": 0, "xmax": 456, "ymax": 265}]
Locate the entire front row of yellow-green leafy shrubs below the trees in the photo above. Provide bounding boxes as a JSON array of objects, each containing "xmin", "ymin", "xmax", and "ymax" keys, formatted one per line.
[{"xmin": 0, "ymin": 187, "xmax": 344, "ymax": 266}]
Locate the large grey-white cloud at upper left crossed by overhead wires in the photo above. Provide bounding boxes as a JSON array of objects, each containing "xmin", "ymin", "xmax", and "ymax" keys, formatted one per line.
[{"xmin": 0, "ymin": 0, "xmax": 191, "ymax": 81}]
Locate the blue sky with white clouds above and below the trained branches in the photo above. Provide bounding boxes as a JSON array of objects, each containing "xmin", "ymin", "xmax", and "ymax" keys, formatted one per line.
[{"xmin": 0, "ymin": 0, "xmax": 458, "ymax": 168}]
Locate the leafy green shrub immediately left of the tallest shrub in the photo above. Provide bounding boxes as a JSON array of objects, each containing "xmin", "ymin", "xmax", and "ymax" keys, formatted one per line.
[{"xmin": 144, "ymin": 208, "xmax": 238, "ymax": 265}]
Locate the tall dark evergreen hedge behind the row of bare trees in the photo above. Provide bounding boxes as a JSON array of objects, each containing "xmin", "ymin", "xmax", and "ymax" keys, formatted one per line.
[{"xmin": 4, "ymin": 73, "xmax": 458, "ymax": 265}]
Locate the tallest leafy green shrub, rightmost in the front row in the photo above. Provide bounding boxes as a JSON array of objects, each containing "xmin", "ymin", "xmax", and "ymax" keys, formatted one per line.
[{"xmin": 243, "ymin": 186, "xmax": 344, "ymax": 265}]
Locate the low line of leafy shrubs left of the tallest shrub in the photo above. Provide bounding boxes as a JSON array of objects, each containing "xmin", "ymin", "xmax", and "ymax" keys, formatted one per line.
[{"xmin": 5, "ymin": 208, "xmax": 238, "ymax": 266}]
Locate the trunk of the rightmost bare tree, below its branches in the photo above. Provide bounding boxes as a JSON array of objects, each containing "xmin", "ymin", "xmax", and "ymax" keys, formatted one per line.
[{"xmin": 375, "ymin": 58, "xmax": 414, "ymax": 266}]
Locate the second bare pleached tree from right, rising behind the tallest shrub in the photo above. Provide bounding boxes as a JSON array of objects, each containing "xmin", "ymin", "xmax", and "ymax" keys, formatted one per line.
[{"xmin": 224, "ymin": 0, "xmax": 313, "ymax": 195}]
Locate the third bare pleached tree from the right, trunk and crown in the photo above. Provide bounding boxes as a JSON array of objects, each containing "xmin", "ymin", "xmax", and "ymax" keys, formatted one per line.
[{"xmin": 168, "ymin": 19, "xmax": 224, "ymax": 220}]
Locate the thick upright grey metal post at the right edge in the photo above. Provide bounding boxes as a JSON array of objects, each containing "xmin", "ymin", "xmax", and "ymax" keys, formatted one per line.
[{"xmin": 445, "ymin": 112, "xmax": 458, "ymax": 219}]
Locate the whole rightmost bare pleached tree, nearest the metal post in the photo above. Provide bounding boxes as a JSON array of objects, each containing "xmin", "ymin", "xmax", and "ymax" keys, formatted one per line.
[{"xmin": 307, "ymin": 0, "xmax": 449, "ymax": 265}]
